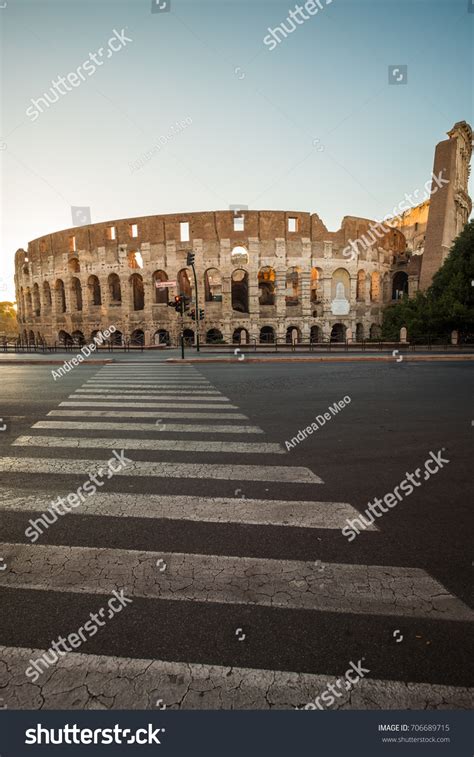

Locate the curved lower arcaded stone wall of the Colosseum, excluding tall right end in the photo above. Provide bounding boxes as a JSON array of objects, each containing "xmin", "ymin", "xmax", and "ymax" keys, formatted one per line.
[{"xmin": 15, "ymin": 211, "xmax": 407, "ymax": 346}]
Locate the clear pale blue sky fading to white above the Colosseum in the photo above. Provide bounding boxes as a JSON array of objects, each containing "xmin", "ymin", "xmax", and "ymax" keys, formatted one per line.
[{"xmin": 0, "ymin": 0, "xmax": 474, "ymax": 300}]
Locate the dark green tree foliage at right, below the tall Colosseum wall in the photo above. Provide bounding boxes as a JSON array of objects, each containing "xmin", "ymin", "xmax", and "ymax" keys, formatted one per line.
[{"xmin": 382, "ymin": 220, "xmax": 474, "ymax": 341}]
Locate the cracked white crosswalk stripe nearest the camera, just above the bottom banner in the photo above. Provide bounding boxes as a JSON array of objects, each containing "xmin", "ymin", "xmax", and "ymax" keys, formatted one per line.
[{"xmin": 0, "ymin": 647, "xmax": 472, "ymax": 710}]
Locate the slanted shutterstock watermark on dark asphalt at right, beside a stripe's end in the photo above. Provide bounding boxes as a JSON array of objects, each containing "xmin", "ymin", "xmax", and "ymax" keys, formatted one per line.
[{"xmin": 342, "ymin": 447, "xmax": 449, "ymax": 541}]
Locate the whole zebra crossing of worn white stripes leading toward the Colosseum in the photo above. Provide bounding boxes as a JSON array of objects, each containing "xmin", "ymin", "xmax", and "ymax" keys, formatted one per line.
[{"xmin": 0, "ymin": 363, "xmax": 473, "ymax": 709}]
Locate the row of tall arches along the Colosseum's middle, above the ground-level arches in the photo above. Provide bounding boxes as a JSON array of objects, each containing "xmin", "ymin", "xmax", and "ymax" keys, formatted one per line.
[{"xmin": 20, "ymin": 266, "xmax": 408, "ymax": 316}]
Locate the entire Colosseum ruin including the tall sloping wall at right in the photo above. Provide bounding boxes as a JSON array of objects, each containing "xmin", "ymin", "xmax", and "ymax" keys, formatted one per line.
[{"xmin": 15, "ymin": 122, "xmax": 472, "ymax": 347}]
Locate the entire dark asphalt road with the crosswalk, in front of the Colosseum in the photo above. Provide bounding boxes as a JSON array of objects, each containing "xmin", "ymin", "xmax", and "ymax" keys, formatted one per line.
[{"xmin": 0, "ymin": 357, "xmax": 474, "ymax": 709}]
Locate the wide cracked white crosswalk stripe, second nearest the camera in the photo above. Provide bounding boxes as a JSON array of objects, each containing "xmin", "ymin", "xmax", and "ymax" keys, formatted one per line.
[{"xmin": 0, "ymin": 543, "xmax": 474, "ymax": 620}]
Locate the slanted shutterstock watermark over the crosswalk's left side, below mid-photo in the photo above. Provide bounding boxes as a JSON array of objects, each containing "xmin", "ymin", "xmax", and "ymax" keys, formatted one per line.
[{"xmin": 25, "ymin": 449, "xmax": 133, "ymax": 544}]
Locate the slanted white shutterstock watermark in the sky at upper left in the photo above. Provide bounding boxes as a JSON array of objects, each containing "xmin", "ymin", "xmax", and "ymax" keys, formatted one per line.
[{"xmin": 26, "ymin": 27, "xmax": 133, "ymax": 123}]
